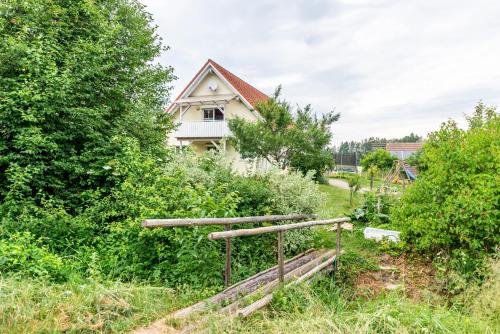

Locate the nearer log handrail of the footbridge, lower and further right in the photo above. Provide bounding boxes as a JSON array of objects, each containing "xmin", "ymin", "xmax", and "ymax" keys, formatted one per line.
[{"xmin": 208, "ymin": 217, "xmax": 351, "ymax": 240}]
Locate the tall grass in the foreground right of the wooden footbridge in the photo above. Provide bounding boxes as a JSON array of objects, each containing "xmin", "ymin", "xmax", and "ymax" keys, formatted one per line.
[{"xmin": 206, "ymin": 278, "xmax": 498, "ymax": 334}]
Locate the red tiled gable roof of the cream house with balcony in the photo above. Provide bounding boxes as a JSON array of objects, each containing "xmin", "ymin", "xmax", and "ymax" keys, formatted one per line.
[{"xmin": 167, "ymin": 59, "xmax": 269, "ymax": 111}]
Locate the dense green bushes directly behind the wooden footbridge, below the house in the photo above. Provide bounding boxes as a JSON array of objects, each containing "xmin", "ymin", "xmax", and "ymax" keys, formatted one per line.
[{"xmin": 0, "ymin": 140, "xmax": 322, "ymax": 286}]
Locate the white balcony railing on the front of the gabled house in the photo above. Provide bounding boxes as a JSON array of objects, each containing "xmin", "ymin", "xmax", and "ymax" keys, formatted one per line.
[{"xmin": 174, "ymin": 121, "xmax": 231, "ymax": 139}]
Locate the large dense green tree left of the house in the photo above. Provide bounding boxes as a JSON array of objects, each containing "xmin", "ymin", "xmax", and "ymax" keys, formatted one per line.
[{"xmin": 0, "ymin": 0, "xmax": 174, "ymax": 207}]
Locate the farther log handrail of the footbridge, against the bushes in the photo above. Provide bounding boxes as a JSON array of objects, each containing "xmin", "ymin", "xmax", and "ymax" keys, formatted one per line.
[{"xmin": 142, "ymin": 213, "xmax": 316, "ymax": 228}]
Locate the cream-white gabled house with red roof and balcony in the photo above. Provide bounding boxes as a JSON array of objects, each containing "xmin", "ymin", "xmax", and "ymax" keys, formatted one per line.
[{"xmin": 167, "ymin": 59, "xmax": 268, "ymax": 171}]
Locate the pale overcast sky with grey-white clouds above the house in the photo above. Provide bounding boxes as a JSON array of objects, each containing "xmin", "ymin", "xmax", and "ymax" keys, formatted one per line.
[{"xmin": 142, "ymin": 0, "xmax": 500, "ymax": 144}]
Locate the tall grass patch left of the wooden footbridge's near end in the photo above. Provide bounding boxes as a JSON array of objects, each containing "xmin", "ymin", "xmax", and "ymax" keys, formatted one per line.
[{"xmin": 0, "ymin": 277, "xmax": 205, "ymax": 334}]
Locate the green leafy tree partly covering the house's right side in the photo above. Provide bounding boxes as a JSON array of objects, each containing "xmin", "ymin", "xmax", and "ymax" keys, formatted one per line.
[{"xmin": 229, "ymin": 87, "xmax": 340, "ymax": 177}]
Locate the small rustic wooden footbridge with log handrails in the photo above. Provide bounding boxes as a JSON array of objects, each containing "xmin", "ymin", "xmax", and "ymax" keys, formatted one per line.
[{"xmin": 134, "ymin": 214, "xmax": 352, "ymax": 334}]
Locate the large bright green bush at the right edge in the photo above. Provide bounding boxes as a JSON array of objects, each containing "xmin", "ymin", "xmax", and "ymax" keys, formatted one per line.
[{"xmin": 394, "ymin": 103, "xmax": 500, "ymax": 277}]
